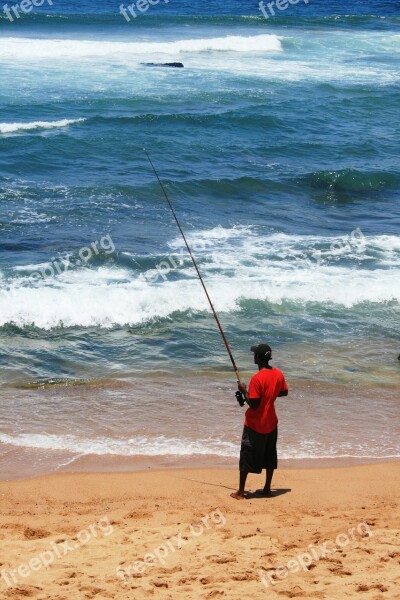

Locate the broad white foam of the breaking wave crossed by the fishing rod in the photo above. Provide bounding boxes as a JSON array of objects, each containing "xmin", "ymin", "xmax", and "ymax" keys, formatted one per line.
[{"xmin": 0, "ymin": 233, "xmax": 400, "ymax": 329}]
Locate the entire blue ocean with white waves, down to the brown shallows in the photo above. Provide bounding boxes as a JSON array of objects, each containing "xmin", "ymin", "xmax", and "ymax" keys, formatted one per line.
[{"xmin": 0, "ymin": 0, "xmax": 400, "ymax": 477}]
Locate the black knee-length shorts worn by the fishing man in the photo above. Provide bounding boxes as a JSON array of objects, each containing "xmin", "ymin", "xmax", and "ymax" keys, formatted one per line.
[{"xmin": 239, "ymin": 425, "xmax": 278, "ymax": 473}]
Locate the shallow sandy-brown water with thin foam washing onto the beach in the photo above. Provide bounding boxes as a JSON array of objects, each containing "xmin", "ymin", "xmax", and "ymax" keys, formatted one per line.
[{"xmin": 0, "ymin": 376, "xmax": 400, "ymax": 479}]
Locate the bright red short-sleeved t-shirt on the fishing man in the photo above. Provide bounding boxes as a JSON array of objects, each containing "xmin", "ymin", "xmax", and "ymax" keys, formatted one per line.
[{"xmin": 244, "ymin": 367, "xmax": 288, "ymax": 433}]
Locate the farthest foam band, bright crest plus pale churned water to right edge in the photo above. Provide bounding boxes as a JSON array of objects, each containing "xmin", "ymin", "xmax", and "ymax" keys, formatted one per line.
[{"xmin": 0, "ymin": 30, "xmax": 399, "ymax": 89}]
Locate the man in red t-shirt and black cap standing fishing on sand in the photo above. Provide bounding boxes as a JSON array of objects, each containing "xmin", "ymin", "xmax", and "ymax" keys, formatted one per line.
[{"xmin": 231, "ymin": 344, "xmax": 288, "ymax": 500}]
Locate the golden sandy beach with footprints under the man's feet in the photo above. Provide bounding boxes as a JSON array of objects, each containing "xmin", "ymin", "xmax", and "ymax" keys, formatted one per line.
[{"xmin": 0, "ymin": 463, "xmax": 400, "ymax": 600}]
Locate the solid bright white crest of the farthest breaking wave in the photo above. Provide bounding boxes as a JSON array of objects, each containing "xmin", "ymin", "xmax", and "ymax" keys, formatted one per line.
[{"xmin": 0, "ymin": 34, "xmax": 282, "ymax": 60}]
